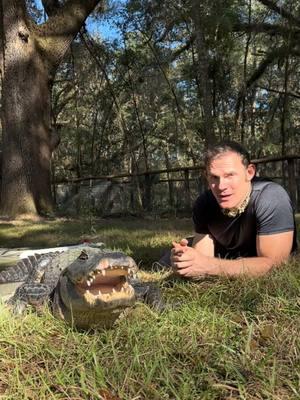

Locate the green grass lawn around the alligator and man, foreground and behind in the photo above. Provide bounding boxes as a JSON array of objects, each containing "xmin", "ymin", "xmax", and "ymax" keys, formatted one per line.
[{"xmin": 0, "ymin": 216, "xmax": 300, "ymax": 400}]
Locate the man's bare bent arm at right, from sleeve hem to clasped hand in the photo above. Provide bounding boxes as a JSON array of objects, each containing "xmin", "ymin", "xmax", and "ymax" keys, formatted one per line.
[{"xmin": 172, "ymin": 231, "xmax": 294, "ymax": 278}]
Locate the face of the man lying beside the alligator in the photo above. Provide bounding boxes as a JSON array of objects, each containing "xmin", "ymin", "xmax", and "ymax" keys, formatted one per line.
[{"xmin": 207, "ymin": 151, "xmax": 255, "ymax": 208}]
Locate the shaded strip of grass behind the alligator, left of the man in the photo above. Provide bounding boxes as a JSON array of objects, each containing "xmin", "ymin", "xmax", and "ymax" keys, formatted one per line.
[{"xmin": 0, "ymin": 218, "xmax": 192, "ymax": 269}]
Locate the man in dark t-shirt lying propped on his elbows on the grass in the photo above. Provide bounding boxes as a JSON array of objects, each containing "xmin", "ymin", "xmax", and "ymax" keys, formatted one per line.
[{"xmin": 171, "ymin": 142, "xmax": 297, "ymax": 278}]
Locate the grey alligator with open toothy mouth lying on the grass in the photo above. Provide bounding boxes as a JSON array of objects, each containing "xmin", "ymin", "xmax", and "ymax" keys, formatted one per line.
[{"xmin": 0, "ymin": 246, "xmax": 164, "ymax": 329}]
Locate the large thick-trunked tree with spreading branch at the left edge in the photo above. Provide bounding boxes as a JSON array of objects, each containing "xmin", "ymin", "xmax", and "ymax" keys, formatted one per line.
[{"xmin": 0, "ymin": 0, "xmax": 101, "ymax": 217}]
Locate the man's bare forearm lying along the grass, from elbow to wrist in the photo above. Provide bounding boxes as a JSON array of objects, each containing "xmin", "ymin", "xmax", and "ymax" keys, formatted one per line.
[{"xmin": 198, "ymin": 257, "xmax": 275, "ymax": 277}]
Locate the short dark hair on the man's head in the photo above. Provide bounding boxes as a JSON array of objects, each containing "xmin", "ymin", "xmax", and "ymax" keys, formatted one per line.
[{"xmin": 204, "ymin": 140, "xmax": 250, "ymax": 168}]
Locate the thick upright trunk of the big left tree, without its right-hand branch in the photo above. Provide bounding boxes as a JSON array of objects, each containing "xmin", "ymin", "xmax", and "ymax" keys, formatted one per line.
[{"xmin": 1, "ymin": 1, "xmax": 52, "ymax": 217}]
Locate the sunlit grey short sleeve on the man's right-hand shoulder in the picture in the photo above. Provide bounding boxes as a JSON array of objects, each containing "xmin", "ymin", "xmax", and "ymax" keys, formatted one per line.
[{"xmin": 255, "ymin": 182, "xmax": 294, "ymax": 235}]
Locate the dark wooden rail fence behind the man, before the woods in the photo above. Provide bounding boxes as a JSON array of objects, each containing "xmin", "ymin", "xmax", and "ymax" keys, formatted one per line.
[{"xmin": 53, "ymin": 155, "xmax": 300, "ymax": 212}]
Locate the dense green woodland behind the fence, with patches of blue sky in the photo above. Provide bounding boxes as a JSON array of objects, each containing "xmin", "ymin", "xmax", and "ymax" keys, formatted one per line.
[{"xmin": 2, "ymin": 0, "xmax": 300, "ymax": 214}]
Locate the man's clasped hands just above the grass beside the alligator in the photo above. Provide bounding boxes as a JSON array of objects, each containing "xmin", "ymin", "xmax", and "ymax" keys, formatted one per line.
[{"xmin": 171, "ymin": 239, "xmax": 207, "ymax": 278}]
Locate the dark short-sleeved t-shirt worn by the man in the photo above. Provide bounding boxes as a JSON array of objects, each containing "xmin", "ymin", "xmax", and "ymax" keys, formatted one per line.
[{"xmin": 193, "ymin": 178, "xmax": 297, "ymax": 259}]
